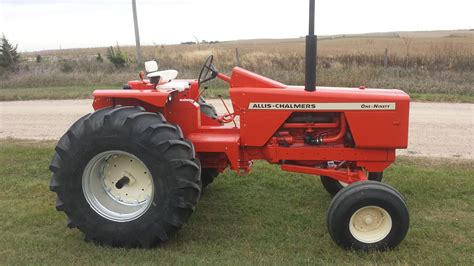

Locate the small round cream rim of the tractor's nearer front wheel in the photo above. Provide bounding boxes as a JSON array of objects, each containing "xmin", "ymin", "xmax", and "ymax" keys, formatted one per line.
[{"xmin": 349, "ymin": 206, "xmax": 392, "ymax": 244}]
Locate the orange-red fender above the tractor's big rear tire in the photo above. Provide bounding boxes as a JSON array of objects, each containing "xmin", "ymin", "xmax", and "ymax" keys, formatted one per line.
[{"xmin": 92, "ymin": 90, "xmax": 175, "ymax": 110}]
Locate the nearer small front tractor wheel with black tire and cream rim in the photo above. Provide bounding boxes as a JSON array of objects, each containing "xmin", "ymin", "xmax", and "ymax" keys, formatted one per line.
[{"xmin": 327, "ymin": 181, "xmax": 410, "ymax": 250}]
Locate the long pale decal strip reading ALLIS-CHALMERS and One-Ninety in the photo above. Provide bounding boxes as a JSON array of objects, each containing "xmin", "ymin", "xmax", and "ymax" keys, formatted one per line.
[{"xmin": 249, "ymin": 102, "xmax": 396, "ymax": 110}]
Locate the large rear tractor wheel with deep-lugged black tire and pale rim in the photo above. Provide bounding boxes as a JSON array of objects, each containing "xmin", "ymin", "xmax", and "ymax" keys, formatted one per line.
[{"xmin": 50, "ymin": 106, "xmax": 201, "ymax": 248}]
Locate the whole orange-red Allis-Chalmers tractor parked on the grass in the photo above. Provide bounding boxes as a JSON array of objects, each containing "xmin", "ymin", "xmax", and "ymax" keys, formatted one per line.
[{"xmin": 50, "ymin": 0, "xmax": 410, "ymax": 250}]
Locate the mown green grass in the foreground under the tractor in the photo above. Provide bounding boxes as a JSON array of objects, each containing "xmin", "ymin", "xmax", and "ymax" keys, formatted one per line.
[{"xmin": 0, "ymin": 141, "xmax": 474, "ymax": 265}]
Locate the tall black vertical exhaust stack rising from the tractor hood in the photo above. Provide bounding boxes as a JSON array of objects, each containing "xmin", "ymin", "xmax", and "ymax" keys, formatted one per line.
[{"xmin": 305, "ymin": 0, "xmax": 318, "ymax": 91}]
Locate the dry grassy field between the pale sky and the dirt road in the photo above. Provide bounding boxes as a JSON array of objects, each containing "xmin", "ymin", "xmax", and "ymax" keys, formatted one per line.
[{"xmin": 0, "ymin": 30, "xmax": 474, "ymax": 102}]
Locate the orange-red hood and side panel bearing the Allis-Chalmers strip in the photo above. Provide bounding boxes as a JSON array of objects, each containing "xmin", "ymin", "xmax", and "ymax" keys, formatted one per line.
[{"xmin": 230, "ymin": 87, "xmax": 410, "ymax": 148}]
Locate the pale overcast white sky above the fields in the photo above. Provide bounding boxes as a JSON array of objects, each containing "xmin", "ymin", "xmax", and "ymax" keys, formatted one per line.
[{"xmin": 0, "ymin": 0, "xmax": 474, "ymax": 52}]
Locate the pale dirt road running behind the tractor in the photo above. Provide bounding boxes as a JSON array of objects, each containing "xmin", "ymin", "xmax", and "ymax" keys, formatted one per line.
[{"xmin": 0, "ymin": 100, "xmax": 474, "ymax": 159}]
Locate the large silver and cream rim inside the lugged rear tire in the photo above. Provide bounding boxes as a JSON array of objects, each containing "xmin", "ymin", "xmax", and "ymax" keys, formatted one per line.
[{"xmin": 82, "ymin": 150, "xmax": 154, "ymax": 222}]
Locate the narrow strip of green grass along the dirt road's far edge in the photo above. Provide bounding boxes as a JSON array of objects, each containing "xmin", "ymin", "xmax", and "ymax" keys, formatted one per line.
[{"xmin": 0, "ymin": 85, "xmax": 474, "ymax": 103}]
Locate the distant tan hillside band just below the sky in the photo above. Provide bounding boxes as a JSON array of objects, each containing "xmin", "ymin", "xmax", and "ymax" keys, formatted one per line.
[{"xmin": 25, "ymin": 30, "xmax": 474, "ymax": 59}]
